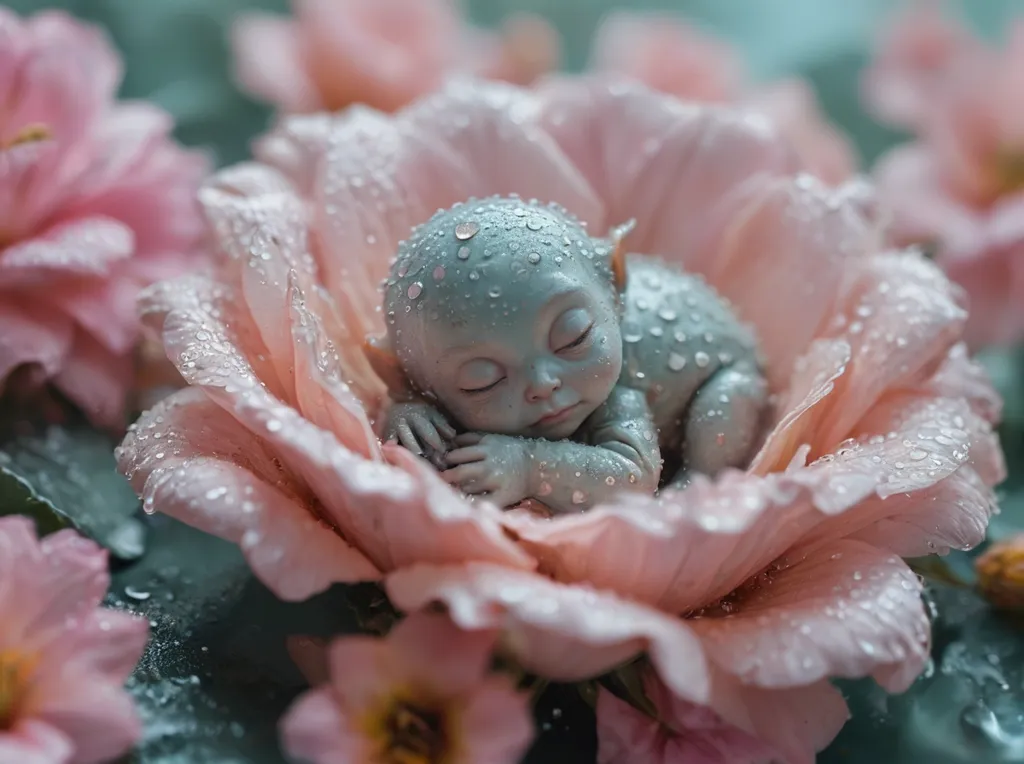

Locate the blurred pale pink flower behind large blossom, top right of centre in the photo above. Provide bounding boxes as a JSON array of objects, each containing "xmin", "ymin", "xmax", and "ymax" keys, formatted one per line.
[{"xmin": 591, "ymin": 11, "xmax": 857, "ymax": 184}]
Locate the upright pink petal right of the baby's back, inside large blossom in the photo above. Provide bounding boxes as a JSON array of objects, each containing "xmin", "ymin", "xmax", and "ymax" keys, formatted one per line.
[{"xmin": 695, "ymin": 175, "xmax": 878, "ymax": 389}]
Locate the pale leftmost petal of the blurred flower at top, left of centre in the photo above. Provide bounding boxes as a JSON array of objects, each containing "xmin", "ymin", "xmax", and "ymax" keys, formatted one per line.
[{"xmin": 230, "ymin": 13, "xmax": 322, "ymax": 112}]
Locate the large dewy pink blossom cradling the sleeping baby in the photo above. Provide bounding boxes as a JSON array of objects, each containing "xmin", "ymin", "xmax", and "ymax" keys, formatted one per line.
[{"xmin": 118, "ymin": 79, "xmax": 1004, "ymax": 763}]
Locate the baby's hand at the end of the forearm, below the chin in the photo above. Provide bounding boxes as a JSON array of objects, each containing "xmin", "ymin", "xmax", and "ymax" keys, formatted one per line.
[{"xmin": 441, "ymin": 432, "xmax": 530, "ymax": 507}]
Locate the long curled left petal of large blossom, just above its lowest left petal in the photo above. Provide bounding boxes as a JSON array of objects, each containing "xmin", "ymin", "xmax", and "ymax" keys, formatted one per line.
[{"xmin": 130, "ymin": 270, "xmax": 531, "ymax": 569}]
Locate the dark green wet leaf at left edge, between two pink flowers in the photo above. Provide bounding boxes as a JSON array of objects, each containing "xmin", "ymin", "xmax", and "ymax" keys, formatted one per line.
[{"xmin": 0, "ymin": 415, "xmax": 144, "ymax": 560}]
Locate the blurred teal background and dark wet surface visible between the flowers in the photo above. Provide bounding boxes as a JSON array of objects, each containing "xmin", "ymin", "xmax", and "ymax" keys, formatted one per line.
[{"xmin": 6, "ymin": 0, "xmax": 1024, "ymax": 764}]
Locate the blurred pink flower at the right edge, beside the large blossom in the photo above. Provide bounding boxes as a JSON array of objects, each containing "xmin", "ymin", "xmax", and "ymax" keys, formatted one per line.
[{"xmin": 876, "ymin": 23, "xmax": 1024, "ymax": 346}]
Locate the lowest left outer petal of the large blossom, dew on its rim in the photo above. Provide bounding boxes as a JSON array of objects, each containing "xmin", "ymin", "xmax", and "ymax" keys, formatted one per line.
[{"xmin": 118, "ymin": 389, "xmax": 379, "ymax": 600}]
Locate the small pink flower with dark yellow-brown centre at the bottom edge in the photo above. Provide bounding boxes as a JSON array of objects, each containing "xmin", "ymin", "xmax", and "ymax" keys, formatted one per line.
[{"xmin": 282, "ymin": 612, "xmax": 532, "ymax": 764}]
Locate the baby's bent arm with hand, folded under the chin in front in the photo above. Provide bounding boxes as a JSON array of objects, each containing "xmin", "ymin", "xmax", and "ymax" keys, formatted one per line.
[{"xmin": 444, "ymin": 386, "xmax": 662, "ymax": 512}]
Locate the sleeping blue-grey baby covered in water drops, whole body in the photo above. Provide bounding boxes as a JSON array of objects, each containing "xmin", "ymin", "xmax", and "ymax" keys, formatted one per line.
[{"xmin": 378, "ymin": 198, "xmax": 767, "ymax": 512}]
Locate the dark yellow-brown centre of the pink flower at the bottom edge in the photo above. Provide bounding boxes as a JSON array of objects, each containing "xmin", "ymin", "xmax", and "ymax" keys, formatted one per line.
[{"xmin": 367, "ymin": 696, "xmax": 455, "ymax": 764}]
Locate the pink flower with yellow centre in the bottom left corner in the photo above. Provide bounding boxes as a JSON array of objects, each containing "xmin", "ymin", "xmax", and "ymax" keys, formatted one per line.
[{"xmin": 0, "ymin": 516, "xmax": 147, "ymax": 764}]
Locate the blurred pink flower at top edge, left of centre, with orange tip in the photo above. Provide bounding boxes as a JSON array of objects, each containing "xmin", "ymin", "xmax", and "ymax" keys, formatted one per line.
[{"xmin": 232, "ymin": 0, "xmax": 561, "ymax": 113}]
